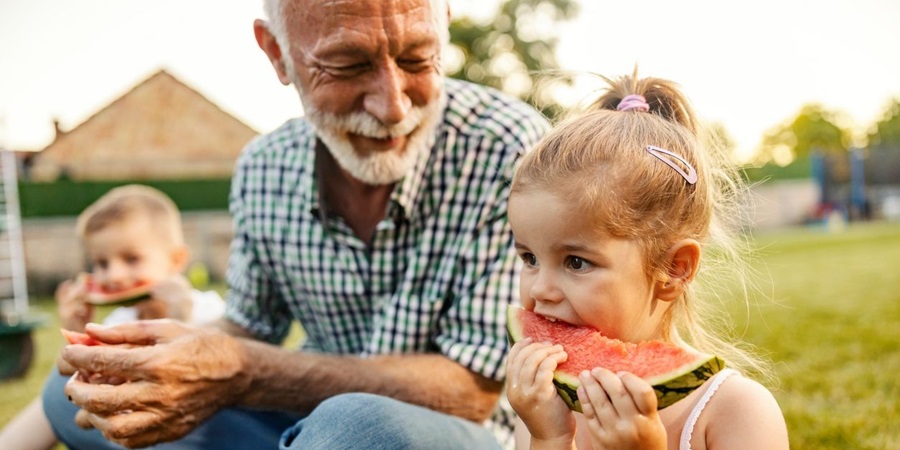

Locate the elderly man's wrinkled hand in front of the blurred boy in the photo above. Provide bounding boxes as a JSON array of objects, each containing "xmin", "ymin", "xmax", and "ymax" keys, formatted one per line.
[{"xmin": 62, "ymin": 320, "xmax": 250, "ymax": 447}]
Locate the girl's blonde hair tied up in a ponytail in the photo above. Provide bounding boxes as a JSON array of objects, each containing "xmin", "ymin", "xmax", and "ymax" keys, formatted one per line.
[{"xmin": 512, "ymin": 70, "xmax": 768, "ymax": 377}]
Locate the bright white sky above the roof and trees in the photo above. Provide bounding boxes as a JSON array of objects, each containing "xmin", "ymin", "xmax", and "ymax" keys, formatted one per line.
[{"xmin": 0, "ymin": 0, "xmax": 900, "ymax": 162}]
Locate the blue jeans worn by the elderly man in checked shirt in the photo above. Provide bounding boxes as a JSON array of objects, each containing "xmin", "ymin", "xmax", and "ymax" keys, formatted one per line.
[{"xmin": 42, "ymin": 371, "xmax": 500, "ymax": 450}]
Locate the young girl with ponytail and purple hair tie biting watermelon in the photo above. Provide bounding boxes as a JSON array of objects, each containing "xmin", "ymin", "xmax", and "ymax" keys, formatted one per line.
[{"xmin": 507, "ymin": 74, "xmax": 788, "ymax": 450}]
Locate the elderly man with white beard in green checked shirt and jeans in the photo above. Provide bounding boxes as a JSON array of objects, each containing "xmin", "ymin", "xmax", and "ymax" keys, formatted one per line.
[{"xmin": 45, "ymin": 0, "xmax": 547, "ymax": 449}]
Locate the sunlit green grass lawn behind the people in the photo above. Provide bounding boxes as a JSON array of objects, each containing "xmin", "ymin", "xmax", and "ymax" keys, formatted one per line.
[{"xmin": 0, "ymin": 224, "xmax": 900, "ymax": 449}]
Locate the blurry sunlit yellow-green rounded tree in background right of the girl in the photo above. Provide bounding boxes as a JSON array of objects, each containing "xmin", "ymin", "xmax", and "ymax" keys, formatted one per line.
[{"xmin": 759, "ymin": 104, "xmax": 850, "ymax": 162}]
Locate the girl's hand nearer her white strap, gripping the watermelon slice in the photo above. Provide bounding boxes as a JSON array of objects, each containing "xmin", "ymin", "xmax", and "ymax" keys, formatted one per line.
[{"xmin": 578, "ymin": 368, "xmax": 666, "ymax": 450}]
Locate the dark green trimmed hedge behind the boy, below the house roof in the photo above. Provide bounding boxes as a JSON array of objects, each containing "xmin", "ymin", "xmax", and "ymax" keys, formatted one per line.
[{"xmin": 19, "ymin": 179, "xmax": 231, "ymax": 217}]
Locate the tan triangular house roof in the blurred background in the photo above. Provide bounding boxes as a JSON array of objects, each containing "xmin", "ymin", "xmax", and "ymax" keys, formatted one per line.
[{"xmin": 34, "ymin": 70, "xmax": 258, "ymax": 177}]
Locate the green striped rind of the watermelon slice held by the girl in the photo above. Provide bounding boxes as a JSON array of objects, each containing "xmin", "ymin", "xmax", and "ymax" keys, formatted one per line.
[{"xmin": 506, "ymin": 306, "xmax": 725, "ymax": 412}]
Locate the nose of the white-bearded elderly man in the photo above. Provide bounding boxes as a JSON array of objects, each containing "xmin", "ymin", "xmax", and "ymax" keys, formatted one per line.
[{"xmin": 363, "ymin": 63, "xmax": 412, "ymax": 126}]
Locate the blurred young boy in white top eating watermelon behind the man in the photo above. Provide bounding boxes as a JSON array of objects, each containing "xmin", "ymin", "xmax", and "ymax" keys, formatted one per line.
[{"xmin": 0, "ymin": 185, "xmax": 225, "ymax": 450}]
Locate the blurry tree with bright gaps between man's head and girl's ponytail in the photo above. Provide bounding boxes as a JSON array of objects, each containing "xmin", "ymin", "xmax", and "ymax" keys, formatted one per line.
[{"xmin": 447, "ymin": 0, "xmax": 578, "ymax": 117}]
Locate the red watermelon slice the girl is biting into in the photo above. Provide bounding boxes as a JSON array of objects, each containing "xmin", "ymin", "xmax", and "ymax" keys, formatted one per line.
[{"xmin": 507, "ymin": 306, "xmax": 725, "ymax": 412}]
